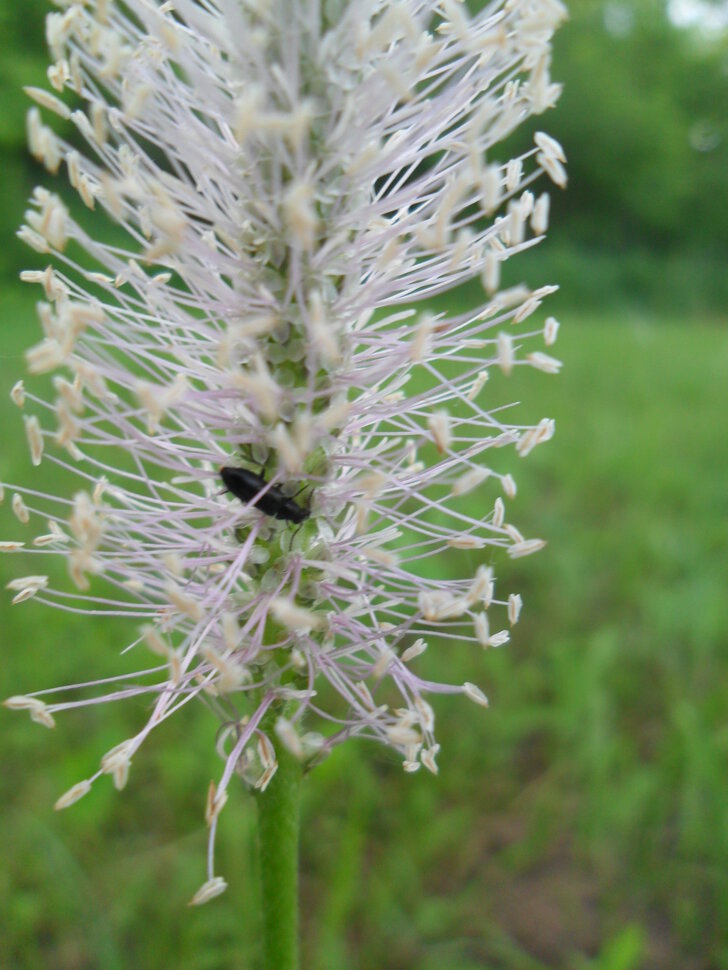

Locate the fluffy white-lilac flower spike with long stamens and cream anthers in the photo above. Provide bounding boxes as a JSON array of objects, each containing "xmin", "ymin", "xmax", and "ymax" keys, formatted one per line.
[{"xmin": 0, "ymin": 0, "xmax": 565, "ymax": 902}]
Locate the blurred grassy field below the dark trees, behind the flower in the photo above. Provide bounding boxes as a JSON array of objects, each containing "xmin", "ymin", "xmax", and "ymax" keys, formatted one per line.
[{"xmin": 0, "ymin": 290, "xmax": 728, "ymax": 970}]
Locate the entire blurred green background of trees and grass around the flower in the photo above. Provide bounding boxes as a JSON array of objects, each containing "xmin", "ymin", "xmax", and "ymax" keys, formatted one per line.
[{"xmin": 0, "ymin": 0, "xmax": 728, "ymax": 970}]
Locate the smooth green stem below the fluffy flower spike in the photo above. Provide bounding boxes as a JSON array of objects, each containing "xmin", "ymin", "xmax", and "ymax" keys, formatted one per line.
[{"xmin": 256, "ymin": 743, "xmax": 301, "ymax": 970}]
